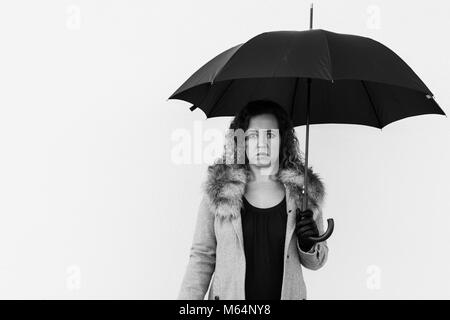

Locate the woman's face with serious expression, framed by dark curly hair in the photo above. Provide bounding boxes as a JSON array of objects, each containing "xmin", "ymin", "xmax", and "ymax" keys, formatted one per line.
[{"xmin": 245, "ymin": 114, "xmax": 280, "ymax": 167}]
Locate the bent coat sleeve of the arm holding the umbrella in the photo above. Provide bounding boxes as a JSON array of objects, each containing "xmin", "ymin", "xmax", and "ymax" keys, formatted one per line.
[{"xmin": 297, "ymin": 206, "xmax": 328, "ymax": 270}]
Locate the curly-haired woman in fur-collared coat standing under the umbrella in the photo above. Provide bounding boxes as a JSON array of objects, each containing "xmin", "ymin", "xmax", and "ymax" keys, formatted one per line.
[{"xmin": 178, "ymin": 100, "xmax": 328, "ymax": 300}]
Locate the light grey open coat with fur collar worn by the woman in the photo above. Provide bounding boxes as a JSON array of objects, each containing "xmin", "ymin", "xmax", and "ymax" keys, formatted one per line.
[{"xmin": 178, "ymin": 164, "xmax": 328, "ymax": 300}]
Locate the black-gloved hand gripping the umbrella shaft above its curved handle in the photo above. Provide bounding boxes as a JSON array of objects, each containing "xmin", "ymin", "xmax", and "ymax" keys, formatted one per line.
[{"xmin": 295, "ymin": 208, "xmax": 319, "ymax": 252}]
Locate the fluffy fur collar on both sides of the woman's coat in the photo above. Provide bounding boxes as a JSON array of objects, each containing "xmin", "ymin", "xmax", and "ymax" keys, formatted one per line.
[{"xmin": 203, "ymin": 163, "xmax": 325, "ymax": 219}]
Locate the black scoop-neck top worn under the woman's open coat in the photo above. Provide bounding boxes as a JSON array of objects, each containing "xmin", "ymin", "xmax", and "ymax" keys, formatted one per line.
[{"xmin": 241, "ymin": 196, "xmax": 287, "ymax": 300}]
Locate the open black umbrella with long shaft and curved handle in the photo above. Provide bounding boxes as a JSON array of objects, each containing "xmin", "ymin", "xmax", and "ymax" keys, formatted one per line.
[{"xmin": 169, "ymin": 6, "xmax": 445, "ymax": 242}]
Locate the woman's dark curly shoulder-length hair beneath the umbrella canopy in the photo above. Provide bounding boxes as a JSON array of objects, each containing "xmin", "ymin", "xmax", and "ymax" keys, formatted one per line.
[{"xmin": 221, "ymin": 100, "xmax": 303, "ymax": 170}]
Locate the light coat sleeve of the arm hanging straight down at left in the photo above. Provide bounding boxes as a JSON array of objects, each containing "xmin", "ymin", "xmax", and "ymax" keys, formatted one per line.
[{"xmin": 178, "ymin": 196, "xmax": 216, "ymax": 300}]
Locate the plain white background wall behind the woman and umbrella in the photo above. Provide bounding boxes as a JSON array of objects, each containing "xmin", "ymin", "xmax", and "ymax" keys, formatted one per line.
[{"xmin": 0, "ymin": 0, "xmax": 450, "ymax": 299}]
